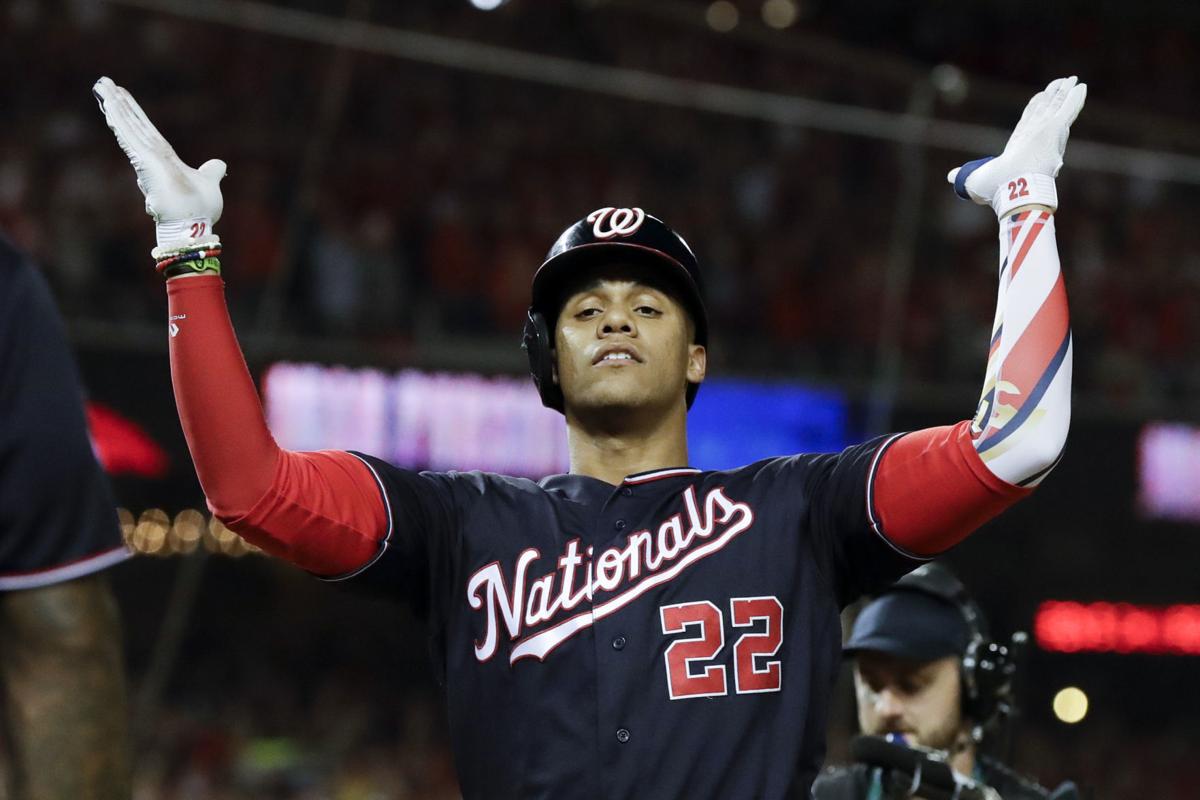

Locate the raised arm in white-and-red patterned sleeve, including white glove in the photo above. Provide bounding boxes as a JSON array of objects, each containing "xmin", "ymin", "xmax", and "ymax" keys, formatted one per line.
[{"xmin": 871, "ymin": 78, "xmax": 1087, "ymax": 557}]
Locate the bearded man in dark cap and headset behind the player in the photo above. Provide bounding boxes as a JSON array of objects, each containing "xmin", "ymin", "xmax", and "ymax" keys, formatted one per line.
[{"xmin": 812, "ymin": 561, "xmax": 1079, "ymax": 800}]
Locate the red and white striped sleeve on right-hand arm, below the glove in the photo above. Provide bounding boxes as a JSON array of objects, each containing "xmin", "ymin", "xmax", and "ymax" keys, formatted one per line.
[{"xmin": 868, "ymin": 210, "xmax": 1072, "ymax": 558}]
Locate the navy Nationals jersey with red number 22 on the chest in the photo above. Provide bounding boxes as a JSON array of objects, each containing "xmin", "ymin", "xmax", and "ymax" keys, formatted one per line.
[{"xmin": 341, "ymin": 439, "xmax": 917, "ymax": 800}]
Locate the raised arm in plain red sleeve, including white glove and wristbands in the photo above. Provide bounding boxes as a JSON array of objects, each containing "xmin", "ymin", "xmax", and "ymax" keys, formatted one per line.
[{"xmin": 92, "ymin": 78, "xmax": 388, "ymax": 576}]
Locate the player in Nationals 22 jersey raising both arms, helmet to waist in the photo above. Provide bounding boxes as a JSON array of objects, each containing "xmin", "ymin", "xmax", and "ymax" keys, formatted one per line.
[{"xmin": 95, "ymin": 78, "xmax": 1085, "ymax": 799}]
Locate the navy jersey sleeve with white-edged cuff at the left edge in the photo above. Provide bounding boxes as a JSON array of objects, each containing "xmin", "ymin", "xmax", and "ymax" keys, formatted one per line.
[{"xmin": 0, "ymin": 236, "xmax": 128, "ymax": 590}]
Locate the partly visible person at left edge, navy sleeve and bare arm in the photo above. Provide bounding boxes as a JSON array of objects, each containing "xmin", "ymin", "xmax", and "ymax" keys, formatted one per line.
[{"xmin": 0, "ymin": 236, "xmax": 132, "ymax": 800}]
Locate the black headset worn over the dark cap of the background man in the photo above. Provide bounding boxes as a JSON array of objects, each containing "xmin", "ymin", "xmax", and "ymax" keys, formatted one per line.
[{"xmin": 892, "ymin": 561, "xmax": 1028, "ymax": 741}]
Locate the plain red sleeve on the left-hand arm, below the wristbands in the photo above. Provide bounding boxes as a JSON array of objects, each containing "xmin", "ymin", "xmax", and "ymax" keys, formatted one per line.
[{"xmin": 167, "ymin": 276, "xmax": 388, "ymax": 575}]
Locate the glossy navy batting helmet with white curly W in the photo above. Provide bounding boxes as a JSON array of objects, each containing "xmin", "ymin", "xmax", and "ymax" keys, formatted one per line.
[{"xmin": 521, "ymin": 207, "xmax": 708, "ymax": 411}]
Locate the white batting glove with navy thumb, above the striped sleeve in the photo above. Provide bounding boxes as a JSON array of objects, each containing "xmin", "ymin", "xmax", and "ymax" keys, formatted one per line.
[{"xmin": 946, "ymin": 76, "xmax": 1087, "ymax": 218}]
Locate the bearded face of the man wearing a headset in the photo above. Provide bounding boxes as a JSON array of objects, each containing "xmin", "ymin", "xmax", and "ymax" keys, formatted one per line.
[{"xmin": 854, "ymin": 651, "xmax": 966, "ymax": 751}]
